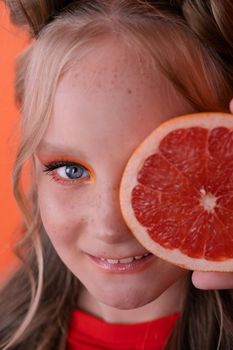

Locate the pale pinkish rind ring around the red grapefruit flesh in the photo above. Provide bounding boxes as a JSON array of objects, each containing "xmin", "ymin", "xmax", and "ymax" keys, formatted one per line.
[{"xmin": 120, "ymin": 113, "xmax": 233, "ymax": 272}]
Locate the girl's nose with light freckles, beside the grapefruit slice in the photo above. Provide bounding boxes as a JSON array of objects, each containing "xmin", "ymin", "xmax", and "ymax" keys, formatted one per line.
[{"xmin": 88, "ymin": 183, "xmax": 134, "ymax": 244}]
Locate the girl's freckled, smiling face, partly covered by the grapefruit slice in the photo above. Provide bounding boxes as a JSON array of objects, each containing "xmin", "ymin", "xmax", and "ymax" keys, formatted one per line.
[{"xmin": 35, "ymin": 40, "xmax": 192, "ymax": 309}]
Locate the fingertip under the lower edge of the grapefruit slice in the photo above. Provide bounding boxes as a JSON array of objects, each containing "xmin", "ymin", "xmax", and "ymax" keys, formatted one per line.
[{"xmin": 192, "ymin": 271, "xmax": 233, "ymax": 290}]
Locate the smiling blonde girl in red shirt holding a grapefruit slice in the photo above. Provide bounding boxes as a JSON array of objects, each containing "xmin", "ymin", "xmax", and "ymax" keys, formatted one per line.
[{"xmin": 0, "ymin": 0, "xmax": 233, "ymax": 350}]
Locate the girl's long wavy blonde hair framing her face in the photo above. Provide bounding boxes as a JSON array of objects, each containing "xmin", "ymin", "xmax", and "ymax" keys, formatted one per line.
[{"xmin": 0, "ymin": 0, "xmax": 233, "ymax": 350}]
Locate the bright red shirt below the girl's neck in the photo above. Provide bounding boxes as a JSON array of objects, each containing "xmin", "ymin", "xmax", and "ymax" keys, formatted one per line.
[{"xmin": 67, "ymin": 310, "xmax": 179, "ymax": 350}]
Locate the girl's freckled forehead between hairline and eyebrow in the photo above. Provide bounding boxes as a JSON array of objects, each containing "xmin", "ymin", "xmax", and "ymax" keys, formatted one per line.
[{"xmin": 39, "ymin": 40, "xmax": 193, "ymax": 160}]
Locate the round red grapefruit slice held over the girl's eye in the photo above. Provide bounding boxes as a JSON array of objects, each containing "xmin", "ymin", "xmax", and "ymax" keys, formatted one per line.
[{"xmin": 120, "ymin": 113, "xmax": 233, "ymax": 271}]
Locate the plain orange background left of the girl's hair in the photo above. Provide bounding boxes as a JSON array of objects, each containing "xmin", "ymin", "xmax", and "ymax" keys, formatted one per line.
[{"xmin": 0, "ymin": 2, "xmax": 28, "ymax": 277}]
